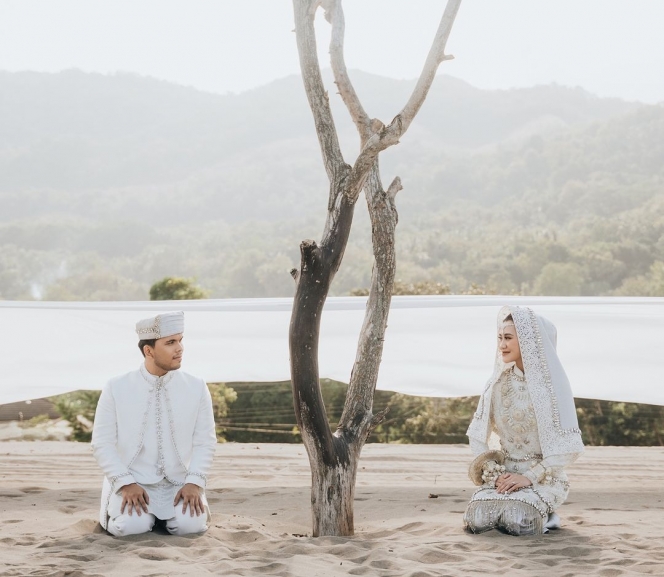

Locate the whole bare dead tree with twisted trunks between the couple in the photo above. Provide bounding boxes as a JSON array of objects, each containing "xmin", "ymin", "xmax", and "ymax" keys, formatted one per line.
[{"xmin": 289, "ymin": 0, "xmax": 461, "ymax": 536}]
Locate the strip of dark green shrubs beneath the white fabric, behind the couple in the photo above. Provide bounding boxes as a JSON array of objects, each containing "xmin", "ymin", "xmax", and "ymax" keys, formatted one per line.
[{"xmin": 51, "ymin": 379, "xmax": 664, "ymax": 446}]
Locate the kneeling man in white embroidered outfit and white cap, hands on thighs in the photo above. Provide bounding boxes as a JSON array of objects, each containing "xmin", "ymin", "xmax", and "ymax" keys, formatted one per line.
[{"xmin": 92, "ymin": 312, "xmax": 217, "ymax": 536}]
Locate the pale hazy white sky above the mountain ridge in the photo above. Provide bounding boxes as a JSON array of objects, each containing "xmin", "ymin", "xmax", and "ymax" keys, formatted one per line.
[{"xmin": 0, "ymin": 0, "xmax": 664, "ymax": 102}]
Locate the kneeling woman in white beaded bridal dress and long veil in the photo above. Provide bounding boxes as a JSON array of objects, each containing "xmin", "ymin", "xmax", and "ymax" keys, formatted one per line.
[{"xmin": 464, "ymin": 307, "xmax": 583, "ymax": 535}]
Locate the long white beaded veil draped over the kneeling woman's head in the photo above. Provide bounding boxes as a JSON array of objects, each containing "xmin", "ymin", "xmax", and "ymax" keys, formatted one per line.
[{"xmin": 468, "ymin": 306, "xmax": 583, "ymax": 458}]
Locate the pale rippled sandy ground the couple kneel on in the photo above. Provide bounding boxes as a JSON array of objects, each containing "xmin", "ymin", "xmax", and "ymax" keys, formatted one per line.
[{"xmin": 0, "ymin": 441, "xmax": 664, "ymax": 577}]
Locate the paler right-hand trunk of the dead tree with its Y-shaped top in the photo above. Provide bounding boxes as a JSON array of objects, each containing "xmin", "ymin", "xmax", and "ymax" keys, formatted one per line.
[{"xmin": 322, "ymin": 0, "xmax": 461, "ymax": 443}]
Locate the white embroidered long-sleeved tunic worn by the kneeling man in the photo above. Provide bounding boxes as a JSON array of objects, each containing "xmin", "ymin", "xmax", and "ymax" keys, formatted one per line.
[{"xmin": 92, "ymin": 366, "xmax": 217, "ymax": 529}]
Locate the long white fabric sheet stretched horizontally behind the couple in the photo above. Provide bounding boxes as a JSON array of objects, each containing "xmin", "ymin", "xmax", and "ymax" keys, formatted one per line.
[{"xmin": 0, "ymin": 296, "xmax": 664, "ymax": 405}]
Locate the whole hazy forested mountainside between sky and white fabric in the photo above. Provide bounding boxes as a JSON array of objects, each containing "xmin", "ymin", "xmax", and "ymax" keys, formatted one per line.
[{"xmin": 0, "ymin": 71, "xmax": 664, "ymax": 300}]
